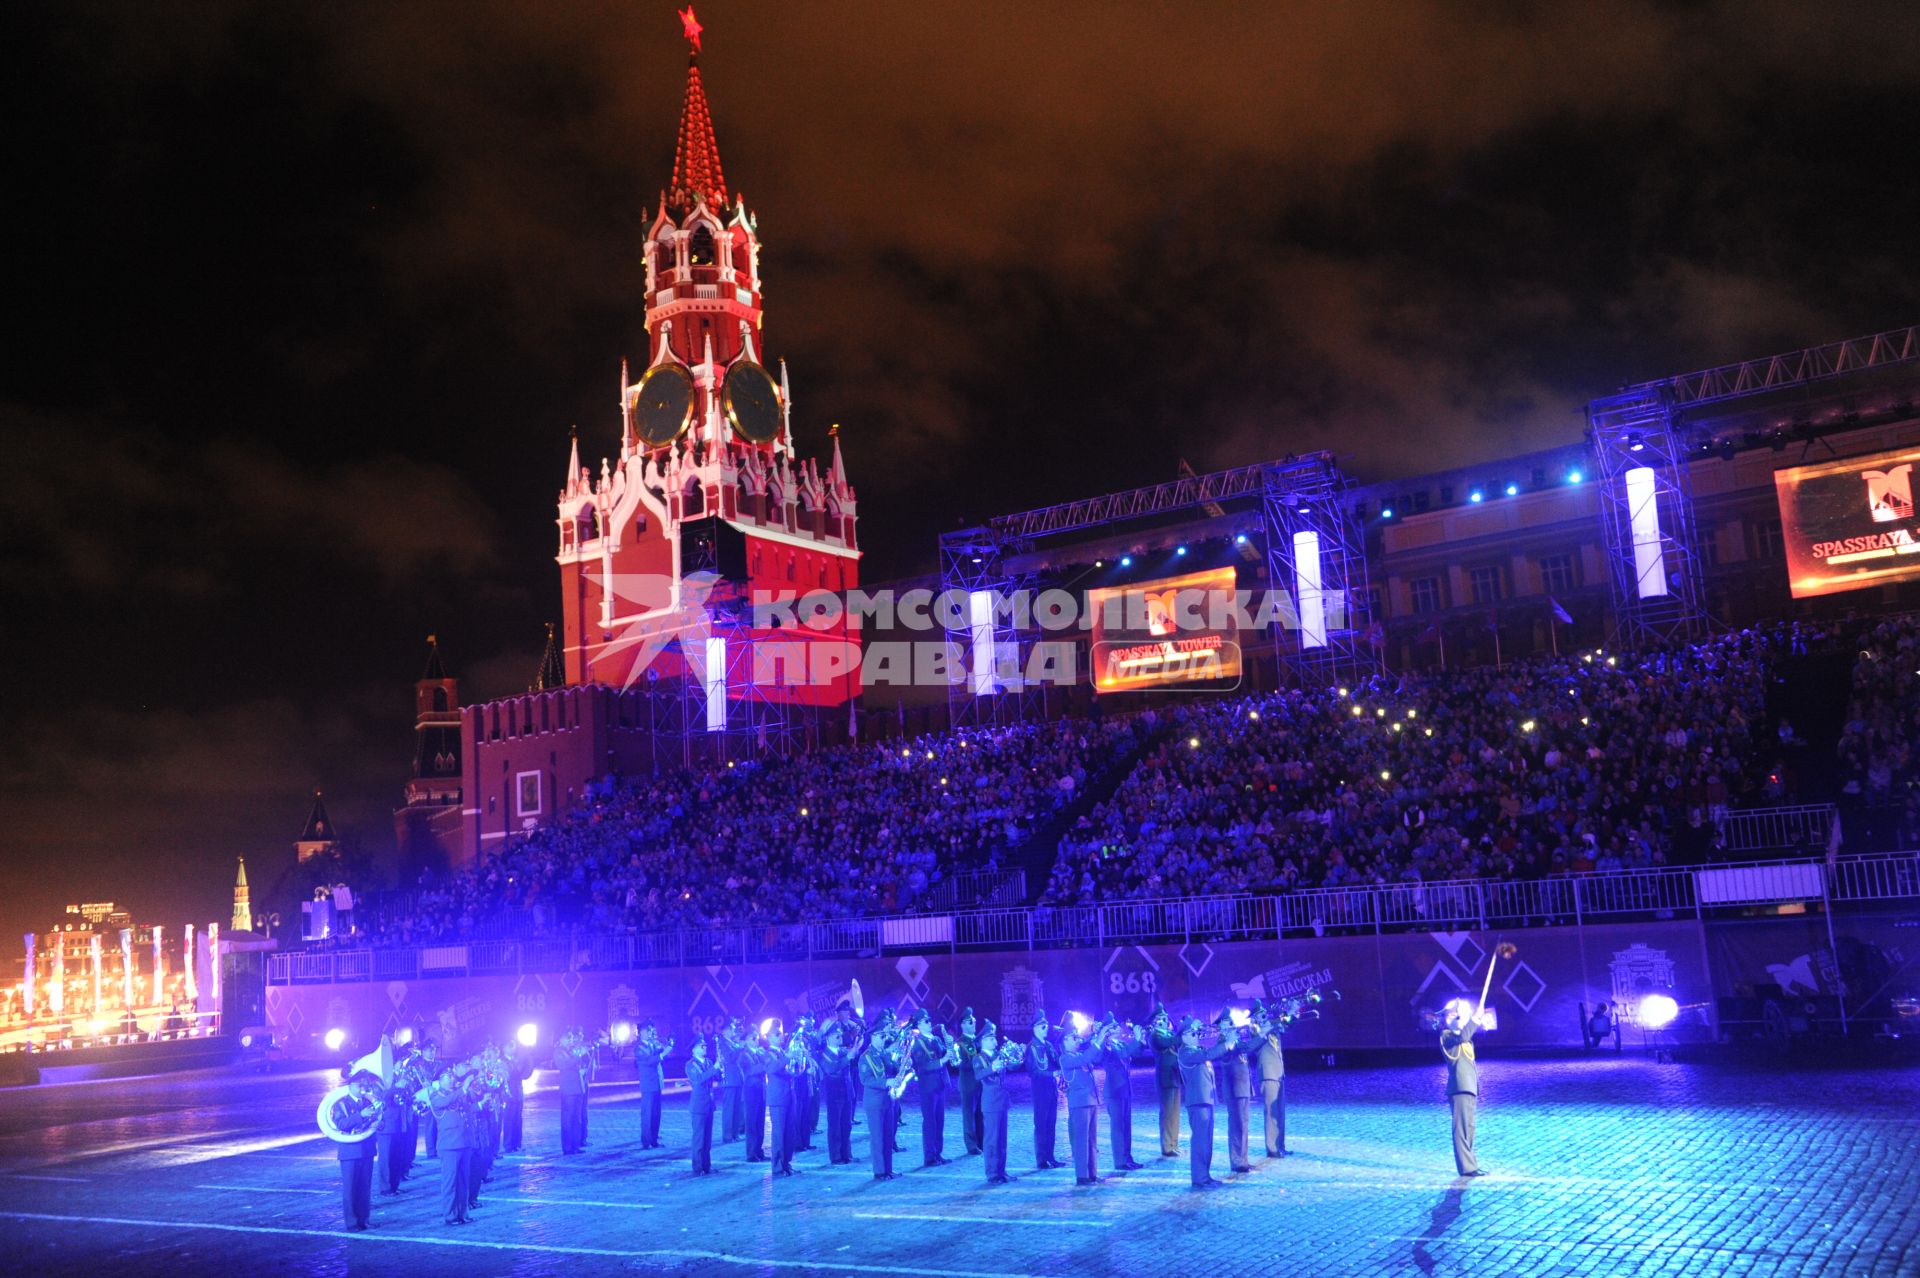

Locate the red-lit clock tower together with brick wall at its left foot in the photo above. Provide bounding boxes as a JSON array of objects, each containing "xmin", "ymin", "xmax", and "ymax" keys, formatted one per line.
[{"xmin": 461, "ymin": 8, "xmax": 860, "ymax": 864}]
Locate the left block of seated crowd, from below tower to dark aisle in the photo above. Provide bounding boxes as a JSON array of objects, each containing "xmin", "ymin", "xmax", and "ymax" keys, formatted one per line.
[{"xmin": 376, "ymin": 720, "xmax": 1135, "ymax": 944}]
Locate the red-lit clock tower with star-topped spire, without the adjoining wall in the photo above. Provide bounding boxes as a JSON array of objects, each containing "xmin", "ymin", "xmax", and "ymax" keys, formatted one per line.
[{"xmin": 559, "ymin": 8, "xmax": 860, "ymax": 706}]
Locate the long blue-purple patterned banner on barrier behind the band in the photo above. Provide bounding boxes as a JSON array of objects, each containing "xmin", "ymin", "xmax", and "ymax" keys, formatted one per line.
[{"xmin": 267, "ymin": 919, "xmax": 1713, "ymax": 1053}]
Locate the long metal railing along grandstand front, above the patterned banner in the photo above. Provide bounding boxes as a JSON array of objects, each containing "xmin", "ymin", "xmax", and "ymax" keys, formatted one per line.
[{"xmin": 267, "ymin": 852, "xmax": 1920, "ymax": 984}]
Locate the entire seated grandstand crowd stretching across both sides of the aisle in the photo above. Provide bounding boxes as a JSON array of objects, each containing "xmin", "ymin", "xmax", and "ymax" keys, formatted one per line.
[{"xmin": 353, "ymin": 618, "xmax": 1920, "ymax": 944}]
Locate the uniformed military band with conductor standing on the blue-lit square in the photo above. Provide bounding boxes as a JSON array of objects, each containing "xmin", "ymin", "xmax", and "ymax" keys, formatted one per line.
[{"xmin": 319, "ymin": 978, "xmax": 1484, "ymax": 1230}]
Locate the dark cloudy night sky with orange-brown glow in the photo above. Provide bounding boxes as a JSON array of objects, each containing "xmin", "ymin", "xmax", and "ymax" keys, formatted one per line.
[{"xmin": 0, "ymin": 0, "xmax": 1920, "ymax": 952}]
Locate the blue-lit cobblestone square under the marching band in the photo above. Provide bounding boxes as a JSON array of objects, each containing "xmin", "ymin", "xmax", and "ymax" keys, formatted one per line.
[{"xmin": 0, "ymin": 1057, "xmax": 1920, "ymax": 1278}]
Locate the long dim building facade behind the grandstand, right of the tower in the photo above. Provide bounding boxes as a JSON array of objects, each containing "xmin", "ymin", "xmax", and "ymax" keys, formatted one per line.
[{"xmin": 921, "ymin": 328, "xmax": 1920, "ymax": 725}]
